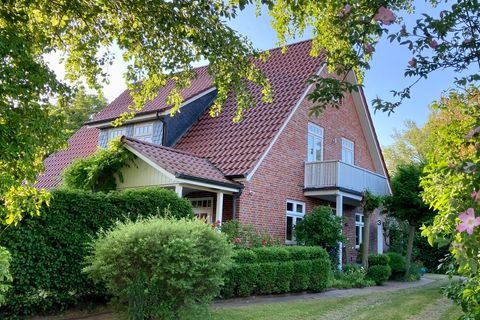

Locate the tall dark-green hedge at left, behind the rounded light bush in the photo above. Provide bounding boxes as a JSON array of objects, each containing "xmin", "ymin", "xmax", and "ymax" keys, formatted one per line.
[{"xmin": 0, "ymin": 188, "xmax": 193, "ymax": 319}]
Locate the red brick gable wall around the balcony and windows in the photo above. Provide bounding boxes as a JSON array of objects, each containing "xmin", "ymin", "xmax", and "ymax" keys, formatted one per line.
[{"xmin": 238, "ymin": 85, "xmax": 376, "ymax": 261}]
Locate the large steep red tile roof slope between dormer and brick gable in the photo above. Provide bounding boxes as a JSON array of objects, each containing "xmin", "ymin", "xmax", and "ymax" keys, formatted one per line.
[{"xmin": 175, "ymin": 41, "xmax": 322, "ymax": 176}]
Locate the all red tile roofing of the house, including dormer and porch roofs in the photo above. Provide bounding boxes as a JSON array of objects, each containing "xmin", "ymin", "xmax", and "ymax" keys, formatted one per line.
[{"xmin": 37, "ymin": 41, "xmax": 322, "ymax": 189}]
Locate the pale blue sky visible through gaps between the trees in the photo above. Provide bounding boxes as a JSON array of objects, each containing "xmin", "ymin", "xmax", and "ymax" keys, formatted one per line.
[{"xmin": 47, "ymin": 1, "xmax": 454, "ymax": 146}]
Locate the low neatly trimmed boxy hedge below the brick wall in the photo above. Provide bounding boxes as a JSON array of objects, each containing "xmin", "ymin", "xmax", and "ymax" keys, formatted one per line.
[{"xmin": 221, "ymin": 246, "xmax": 333, "ymax": 298}]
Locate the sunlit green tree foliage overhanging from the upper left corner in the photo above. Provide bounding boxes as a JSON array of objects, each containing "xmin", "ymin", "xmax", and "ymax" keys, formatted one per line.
[{"xmin": 0, "ymin": 0, "xmax": 271, "ymax": 223}]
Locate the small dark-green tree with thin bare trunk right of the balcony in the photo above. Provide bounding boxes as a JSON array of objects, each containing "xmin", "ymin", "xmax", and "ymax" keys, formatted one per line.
[{"xmin": 384, "ymin": 163, "xmax": 435, "ymax": 276}]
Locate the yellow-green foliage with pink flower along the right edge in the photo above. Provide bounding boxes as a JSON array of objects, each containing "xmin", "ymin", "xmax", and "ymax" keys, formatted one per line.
[{"xmin": 421, "ymin": 88, "xmax": 480, "ymax": 319}]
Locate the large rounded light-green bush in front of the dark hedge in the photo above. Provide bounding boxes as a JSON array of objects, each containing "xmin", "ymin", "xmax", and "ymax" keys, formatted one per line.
[{"xmin": 84, "ymin": 218, "xmax": 231, "ymax": 319}]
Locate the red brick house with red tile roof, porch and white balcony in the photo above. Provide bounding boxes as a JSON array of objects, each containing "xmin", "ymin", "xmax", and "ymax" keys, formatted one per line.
[{"xmin": 37, "ymin": 41, "xmax": 391, "ymax": 263}]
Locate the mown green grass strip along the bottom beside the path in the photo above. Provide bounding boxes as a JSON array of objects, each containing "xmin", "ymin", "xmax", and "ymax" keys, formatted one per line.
[{"xmin": 210, "ymin": 281, "xmax": 461, "ymax": 320}]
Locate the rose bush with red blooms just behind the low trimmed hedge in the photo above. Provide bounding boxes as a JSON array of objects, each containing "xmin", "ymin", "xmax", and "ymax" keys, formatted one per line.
[{"xmin": 222, "ymin": 220, "xmax": 279, "ymax": 249}]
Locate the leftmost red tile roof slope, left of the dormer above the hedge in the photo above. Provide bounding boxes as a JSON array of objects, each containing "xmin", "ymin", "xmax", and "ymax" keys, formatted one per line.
[{"xmin": 36, "ymin": 126, "xmax": 100, "ymax": 189}]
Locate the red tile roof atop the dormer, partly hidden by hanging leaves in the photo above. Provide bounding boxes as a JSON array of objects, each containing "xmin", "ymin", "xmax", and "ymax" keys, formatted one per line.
[{"xmin": 88, "ymin": 66, "xmax": 212, "ymax": 124}]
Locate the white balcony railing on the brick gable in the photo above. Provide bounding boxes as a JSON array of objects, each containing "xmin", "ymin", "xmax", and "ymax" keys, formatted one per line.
[{"xmin": 305, "ymin": 161, "xmax": 389, "ymax": 195}]
